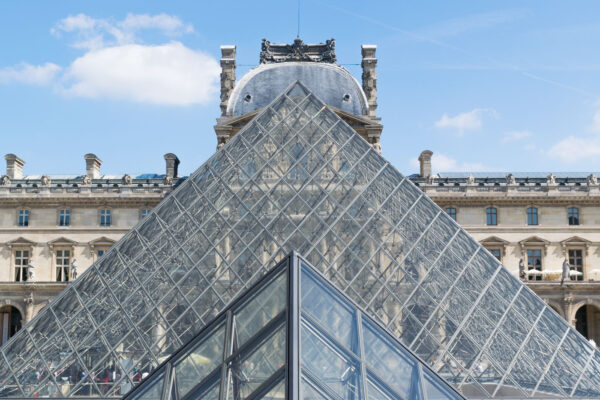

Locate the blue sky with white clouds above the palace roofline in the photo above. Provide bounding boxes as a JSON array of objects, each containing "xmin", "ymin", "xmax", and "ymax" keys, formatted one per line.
[{"xmin": 0, "ymin": 0, "xmax": 600, "ymax": 174}]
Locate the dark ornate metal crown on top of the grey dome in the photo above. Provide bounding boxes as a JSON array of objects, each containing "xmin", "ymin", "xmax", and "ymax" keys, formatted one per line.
[{"xmin": 260, "ymin": 37, "xmax": 337, "ymax": 64}]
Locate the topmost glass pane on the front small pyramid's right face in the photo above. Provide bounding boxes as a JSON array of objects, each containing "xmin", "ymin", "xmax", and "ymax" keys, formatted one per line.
[{"xmin": 300, "ymin": 263, "xmax": 357, "ymax": 352}]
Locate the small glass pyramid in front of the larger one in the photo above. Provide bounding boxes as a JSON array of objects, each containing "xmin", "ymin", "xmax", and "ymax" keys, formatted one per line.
[{"xmin": 124, "ymin": 253, "xmax": 463, "ymax": 400}]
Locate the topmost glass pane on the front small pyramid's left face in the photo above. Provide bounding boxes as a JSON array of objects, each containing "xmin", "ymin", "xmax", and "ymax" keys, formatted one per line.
[{"xmin": 235, "ymin": 273, "xmax": 287, "ymax": 346}]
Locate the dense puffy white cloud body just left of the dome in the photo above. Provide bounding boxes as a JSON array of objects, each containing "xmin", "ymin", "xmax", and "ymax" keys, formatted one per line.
[{"xmin": 64, "ymin": 42, "xmax": 220, "ymax": 105}]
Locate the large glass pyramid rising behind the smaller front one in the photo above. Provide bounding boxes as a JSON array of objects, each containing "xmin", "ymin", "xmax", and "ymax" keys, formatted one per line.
[{"xmin": 0, "ymin": 82, "xmax": 600, "ymax": 397}]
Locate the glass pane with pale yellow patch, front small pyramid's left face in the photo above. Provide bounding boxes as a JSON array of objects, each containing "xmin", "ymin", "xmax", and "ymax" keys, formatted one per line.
[{"xmin": 174, "ymin": 325, "xmax": 225, "ymax": 398}]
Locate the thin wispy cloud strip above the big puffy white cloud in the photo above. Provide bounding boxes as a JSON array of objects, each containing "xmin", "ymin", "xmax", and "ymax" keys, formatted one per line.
[{"xmin": 50, "ymin": 13, "xmax": 194, "ymax": 50}]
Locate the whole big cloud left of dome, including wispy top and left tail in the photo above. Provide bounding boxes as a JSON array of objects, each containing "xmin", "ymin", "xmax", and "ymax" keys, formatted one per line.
[{"xmin": 0, "ymin": 14, "xmax": 220, "ymax": 106}]
